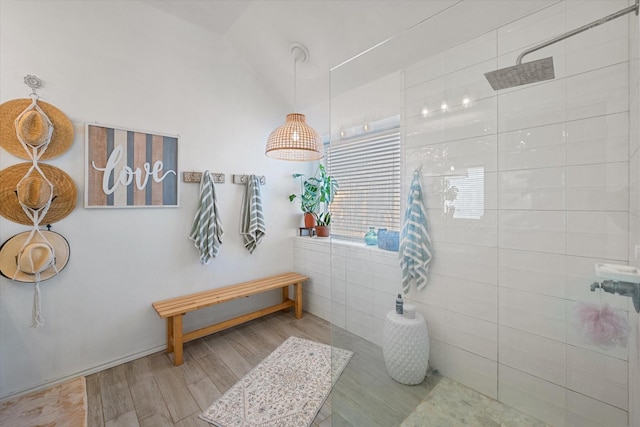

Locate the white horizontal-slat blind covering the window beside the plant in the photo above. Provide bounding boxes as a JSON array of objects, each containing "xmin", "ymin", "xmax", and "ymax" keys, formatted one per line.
[{"xmin": 327, "ymin": 128, "xmax": 400, "ymax": 240}]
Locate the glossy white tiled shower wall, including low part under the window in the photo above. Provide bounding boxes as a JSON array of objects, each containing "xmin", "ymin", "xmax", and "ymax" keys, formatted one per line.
[{"xmin": 295, "ymin": 0, "xmax": 640, "ymax": 427}]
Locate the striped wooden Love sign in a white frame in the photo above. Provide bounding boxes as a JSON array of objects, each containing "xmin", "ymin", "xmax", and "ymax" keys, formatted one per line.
[{"xmin": 84, "ymin": 124, "xmax": 178, "ymax": 208}]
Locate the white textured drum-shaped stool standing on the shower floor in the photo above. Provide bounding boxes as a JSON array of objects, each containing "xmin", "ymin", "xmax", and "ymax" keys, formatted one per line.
[{"xmin": 382, "ymin": 310, "xmax": 429, "ymax": 385}]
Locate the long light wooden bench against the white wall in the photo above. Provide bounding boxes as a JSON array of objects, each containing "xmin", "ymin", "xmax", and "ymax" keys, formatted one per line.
[{"xmin": 152, "ymin": 273, "xmax": 309, "ymax": 366}]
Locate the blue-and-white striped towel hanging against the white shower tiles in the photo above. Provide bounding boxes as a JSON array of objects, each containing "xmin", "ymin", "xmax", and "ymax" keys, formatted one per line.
[{"xmin": 399, "ymin": 169, "xmax": 432, "ymax": 294}]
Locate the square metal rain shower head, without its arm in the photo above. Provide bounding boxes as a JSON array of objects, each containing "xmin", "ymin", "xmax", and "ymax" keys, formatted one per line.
[{"xmin": 484, "ymin": 56, "xmax": 555, "ymax": 90}]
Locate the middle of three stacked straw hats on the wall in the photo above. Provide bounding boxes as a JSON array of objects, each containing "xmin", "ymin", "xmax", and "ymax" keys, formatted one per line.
[{"xmin": 0, "ymin": 163, "xmax": 78, "ymax": 225}]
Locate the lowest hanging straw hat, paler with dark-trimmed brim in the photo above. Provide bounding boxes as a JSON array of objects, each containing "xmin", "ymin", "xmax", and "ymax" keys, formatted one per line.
[{"xmin": 0, "ymin": 230, "xmax": 70, "ymax": 283}]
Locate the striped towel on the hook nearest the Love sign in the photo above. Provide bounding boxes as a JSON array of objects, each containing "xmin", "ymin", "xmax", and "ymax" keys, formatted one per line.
[{"xmin": 189, "ymin": 171, "xmax": 224, "ymax": 264}]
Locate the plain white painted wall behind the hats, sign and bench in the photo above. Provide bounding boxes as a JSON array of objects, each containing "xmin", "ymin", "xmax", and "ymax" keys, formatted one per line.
[{"xmin": 0, "ymin": 0, "xmax": 307, "ymax": 398}]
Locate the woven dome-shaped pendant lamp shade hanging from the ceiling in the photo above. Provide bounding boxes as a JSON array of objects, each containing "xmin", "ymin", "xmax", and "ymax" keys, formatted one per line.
[{"xmin": 265, "ymin": 113, "xmax": 323, "ymax": 162}]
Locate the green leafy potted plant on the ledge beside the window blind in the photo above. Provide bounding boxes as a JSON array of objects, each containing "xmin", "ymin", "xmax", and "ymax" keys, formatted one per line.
[{"xmin": 289, "ymin": 163, "xmax": 338, "ymax": 228}]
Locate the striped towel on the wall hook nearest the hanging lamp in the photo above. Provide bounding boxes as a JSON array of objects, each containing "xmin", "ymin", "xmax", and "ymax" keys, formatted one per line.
[{"xmin": 240, "ymin": 175, "xmax": 266, "ymax": 254}]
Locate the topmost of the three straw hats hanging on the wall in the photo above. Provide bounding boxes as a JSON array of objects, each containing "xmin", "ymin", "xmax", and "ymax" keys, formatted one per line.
[{"xmin": 0, "ymin": 98, "xmax": 75, "ymax": 160}]
